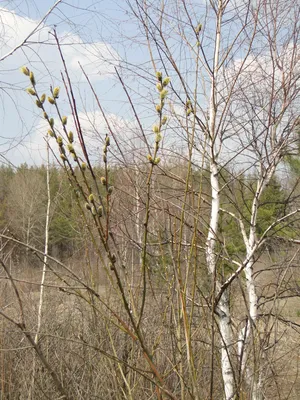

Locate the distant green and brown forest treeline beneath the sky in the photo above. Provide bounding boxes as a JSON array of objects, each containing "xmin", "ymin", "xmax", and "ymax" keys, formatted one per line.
[{"xmin": 0, "ymin": 164, "xmax": 298, "ymax": 263}]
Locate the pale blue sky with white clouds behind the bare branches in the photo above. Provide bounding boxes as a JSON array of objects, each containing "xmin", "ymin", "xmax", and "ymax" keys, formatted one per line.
[{"xmin": 0, "ymin": 0, "xmax": 299, "ymax": 172}]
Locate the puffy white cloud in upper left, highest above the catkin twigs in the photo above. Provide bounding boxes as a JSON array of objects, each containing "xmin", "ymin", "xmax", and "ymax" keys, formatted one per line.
[{"xmin": 0, "ymin": 8, "xmax": 119, "ymax": 82}]
